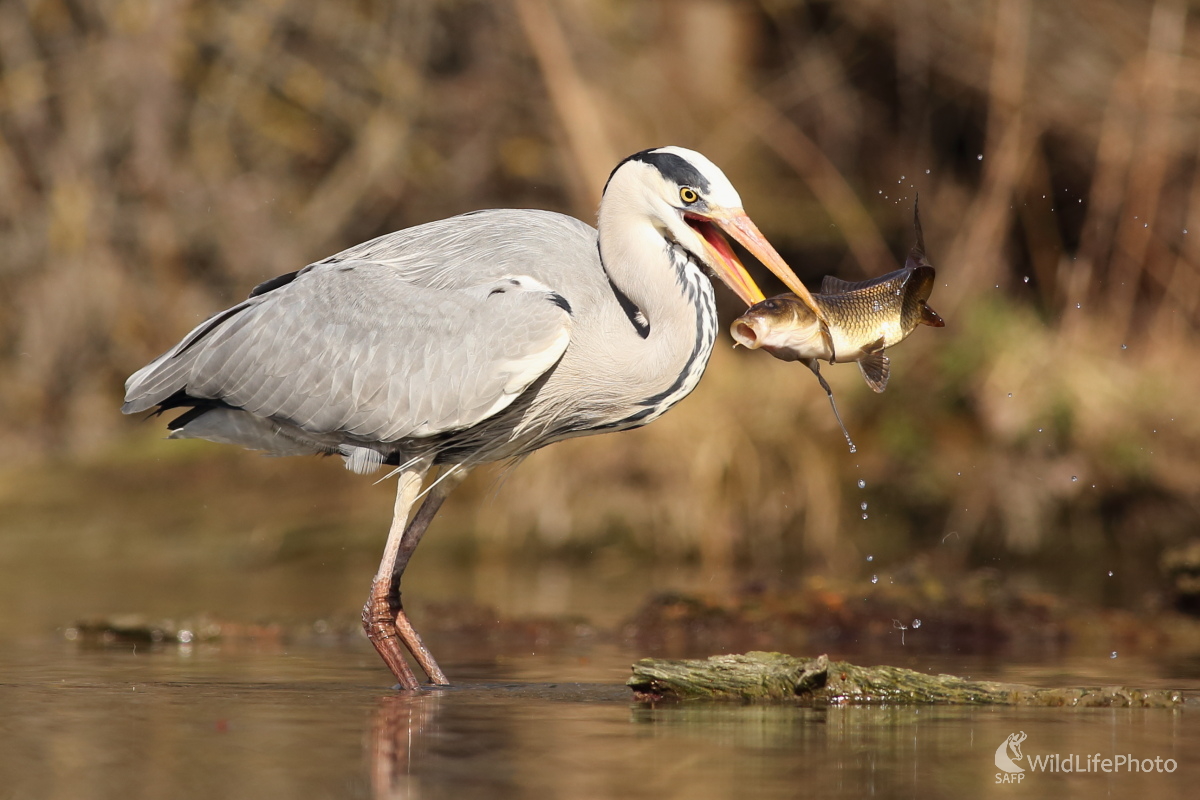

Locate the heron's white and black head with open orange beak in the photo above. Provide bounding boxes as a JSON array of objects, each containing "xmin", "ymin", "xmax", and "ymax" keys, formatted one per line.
[{"xmin": 600, "ymin": 146, "xmax": 824, "ymax": 319}]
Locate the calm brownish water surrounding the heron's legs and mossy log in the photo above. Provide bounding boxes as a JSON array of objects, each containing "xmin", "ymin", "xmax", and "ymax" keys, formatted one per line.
[{"xmin": 0, "ymin": 460, "xmax": 1200, "ymax": 800}]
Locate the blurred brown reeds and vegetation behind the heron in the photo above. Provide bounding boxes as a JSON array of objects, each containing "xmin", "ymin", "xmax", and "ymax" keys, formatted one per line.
[{"xmin": 0, "ymin": 0, "xmax": 1200, "ymax": 633}]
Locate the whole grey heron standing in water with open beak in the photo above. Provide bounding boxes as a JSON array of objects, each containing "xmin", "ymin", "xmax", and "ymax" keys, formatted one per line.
[{"xmin": 121, "ymin": 146, "xmax": 822, "ymax": 688}]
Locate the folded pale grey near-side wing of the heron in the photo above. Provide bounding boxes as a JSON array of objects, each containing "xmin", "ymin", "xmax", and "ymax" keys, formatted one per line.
[{"xmin": 121, "ymin": 261, "xmax": 571, "ymax": 443}]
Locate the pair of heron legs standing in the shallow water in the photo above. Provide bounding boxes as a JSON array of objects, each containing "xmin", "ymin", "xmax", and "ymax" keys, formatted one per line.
[{"xmin": 362, "ymin": 468, "xmax": 468, "ymax": 688}]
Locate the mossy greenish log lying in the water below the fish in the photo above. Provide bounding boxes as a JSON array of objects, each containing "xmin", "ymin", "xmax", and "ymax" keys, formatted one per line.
[{"xmin": 628, "ymin": 652, "xmax": 1183, "ymax": 708}]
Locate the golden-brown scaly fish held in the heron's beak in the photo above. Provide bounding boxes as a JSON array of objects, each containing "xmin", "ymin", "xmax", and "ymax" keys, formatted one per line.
[{"xmin": 731, "ymin": 195, "xmax": 946, "ymax": 392}]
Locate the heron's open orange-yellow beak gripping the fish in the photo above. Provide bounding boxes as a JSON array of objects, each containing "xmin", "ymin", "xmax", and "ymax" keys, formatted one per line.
[{"xmin": 685, "ymin": 209, "xmax": 827, "ymax": 323}]
